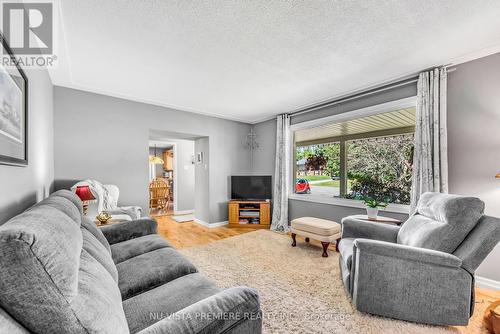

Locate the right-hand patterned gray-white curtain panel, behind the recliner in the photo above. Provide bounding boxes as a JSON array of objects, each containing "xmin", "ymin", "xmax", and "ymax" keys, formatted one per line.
[{"xmin": 410, "ymin": 68, "xmax": 448, "ymax": 213}]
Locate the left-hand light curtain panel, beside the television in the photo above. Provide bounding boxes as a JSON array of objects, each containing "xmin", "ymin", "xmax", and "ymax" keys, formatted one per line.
[{"xmin": 271, "ymin": 114, "xmax": 291, "ymax": 232}]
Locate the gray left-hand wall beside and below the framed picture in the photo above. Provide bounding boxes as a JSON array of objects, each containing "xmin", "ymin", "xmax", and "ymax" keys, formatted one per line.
[{"xmin": 0, "ymin": 70, "xmax": 54, "ymax": 224}]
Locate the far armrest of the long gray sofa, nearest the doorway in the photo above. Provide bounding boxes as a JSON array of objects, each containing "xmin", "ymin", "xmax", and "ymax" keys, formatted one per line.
[{"xmin": 101, "ymin": 218, "xmax": 157, "ymax": 245}]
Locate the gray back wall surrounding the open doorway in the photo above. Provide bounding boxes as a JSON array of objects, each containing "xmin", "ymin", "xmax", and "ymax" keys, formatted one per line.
[{"xmin": 54, "ymin": 87, "xmax": 251, "ymax": 222}]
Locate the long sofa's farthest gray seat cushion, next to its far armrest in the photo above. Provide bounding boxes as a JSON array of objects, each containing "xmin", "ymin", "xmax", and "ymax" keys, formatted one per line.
[{"xmin": 111, "ymin": 234, "xmax": 172, "ymax": 263}]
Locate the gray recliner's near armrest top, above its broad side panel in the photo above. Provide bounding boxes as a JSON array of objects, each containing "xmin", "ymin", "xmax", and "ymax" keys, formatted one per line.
[{"xmin": 354, "ymin": 239, "xmax": 462, "ymax": 268}]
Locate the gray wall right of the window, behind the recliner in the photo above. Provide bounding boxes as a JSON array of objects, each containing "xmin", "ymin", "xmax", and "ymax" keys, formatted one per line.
[{"xmin": 448, "ymin": 53, "xmax": 500, "ymax": 281}]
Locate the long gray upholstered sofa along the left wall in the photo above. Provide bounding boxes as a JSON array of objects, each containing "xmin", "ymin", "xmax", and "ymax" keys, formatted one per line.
[{"xmin": 0, "ymin": 190, "xmax": 262, "ymax": 334}]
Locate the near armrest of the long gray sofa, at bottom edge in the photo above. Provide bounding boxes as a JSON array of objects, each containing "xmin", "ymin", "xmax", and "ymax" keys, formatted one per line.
[{"xmin": 138, "ymin": 287, "xmax": 262, "ymax": 334}]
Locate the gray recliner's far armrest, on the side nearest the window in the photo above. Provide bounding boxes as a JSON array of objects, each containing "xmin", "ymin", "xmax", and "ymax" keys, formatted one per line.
[{"xmin": 342, "ymin": 217, "xmax": 399, "ymax": 242}]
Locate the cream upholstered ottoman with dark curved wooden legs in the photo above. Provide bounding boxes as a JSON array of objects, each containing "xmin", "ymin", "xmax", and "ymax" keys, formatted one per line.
[{"xmin": 292, "ymin": 217, "xmax": 341, "ymax": 257}]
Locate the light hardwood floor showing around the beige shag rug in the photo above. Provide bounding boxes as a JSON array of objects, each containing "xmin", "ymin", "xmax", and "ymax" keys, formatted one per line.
[{"xmin": 154, "ymin": 216, "xmax": 500, "ymax": 334}]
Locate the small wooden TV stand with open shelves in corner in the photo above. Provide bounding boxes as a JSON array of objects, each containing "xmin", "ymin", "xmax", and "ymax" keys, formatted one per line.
[{"xmin": 228, "ymin": 200, "xmax": 271, "ymax": 229}]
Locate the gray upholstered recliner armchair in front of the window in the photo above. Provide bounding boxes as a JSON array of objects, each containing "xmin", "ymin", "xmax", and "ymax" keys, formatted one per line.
[{"xmin": 339, "ymin": 193, "xmax": 500, "ymax": 325}]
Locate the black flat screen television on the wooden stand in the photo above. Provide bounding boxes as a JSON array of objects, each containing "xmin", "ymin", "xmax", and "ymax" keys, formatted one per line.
[{"xmin": 231, "ymin": 175, "xmax": 273, "ymax": 200}]
